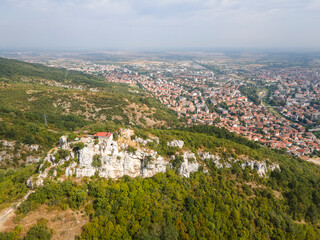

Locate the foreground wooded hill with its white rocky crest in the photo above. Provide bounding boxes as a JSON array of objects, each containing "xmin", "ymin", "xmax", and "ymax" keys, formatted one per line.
[{"xmin": 2, "ymin": 127, "xmax": 320, "ymax": 239}]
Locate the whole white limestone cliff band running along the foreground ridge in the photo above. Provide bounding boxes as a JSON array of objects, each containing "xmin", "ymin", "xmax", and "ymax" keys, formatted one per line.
[{"xmin": 37, "ymin": 131, "xmax": 279, "ymax": 188}]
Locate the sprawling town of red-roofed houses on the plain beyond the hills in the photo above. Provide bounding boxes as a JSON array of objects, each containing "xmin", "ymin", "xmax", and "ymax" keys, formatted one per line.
[{"xmin": 31, "ymin": 55, "xmax": 320, "ymax": 156}]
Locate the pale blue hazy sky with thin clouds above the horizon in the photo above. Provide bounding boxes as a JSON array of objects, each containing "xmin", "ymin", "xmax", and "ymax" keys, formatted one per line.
[{"xmin": 0, "ymin": 0, "xmax": 320, "ymax": 50}]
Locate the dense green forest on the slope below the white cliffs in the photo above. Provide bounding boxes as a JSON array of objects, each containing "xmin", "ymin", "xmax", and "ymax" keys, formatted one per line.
[{"xmin": 13, "ymin": 158, "xmax": 320, "ymax": 239}]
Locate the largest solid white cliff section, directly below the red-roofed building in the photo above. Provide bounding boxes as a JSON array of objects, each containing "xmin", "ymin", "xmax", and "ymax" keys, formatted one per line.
[{"xmin": 66, "ymin": 140, "xmax": 168, "ymax": 178}]
